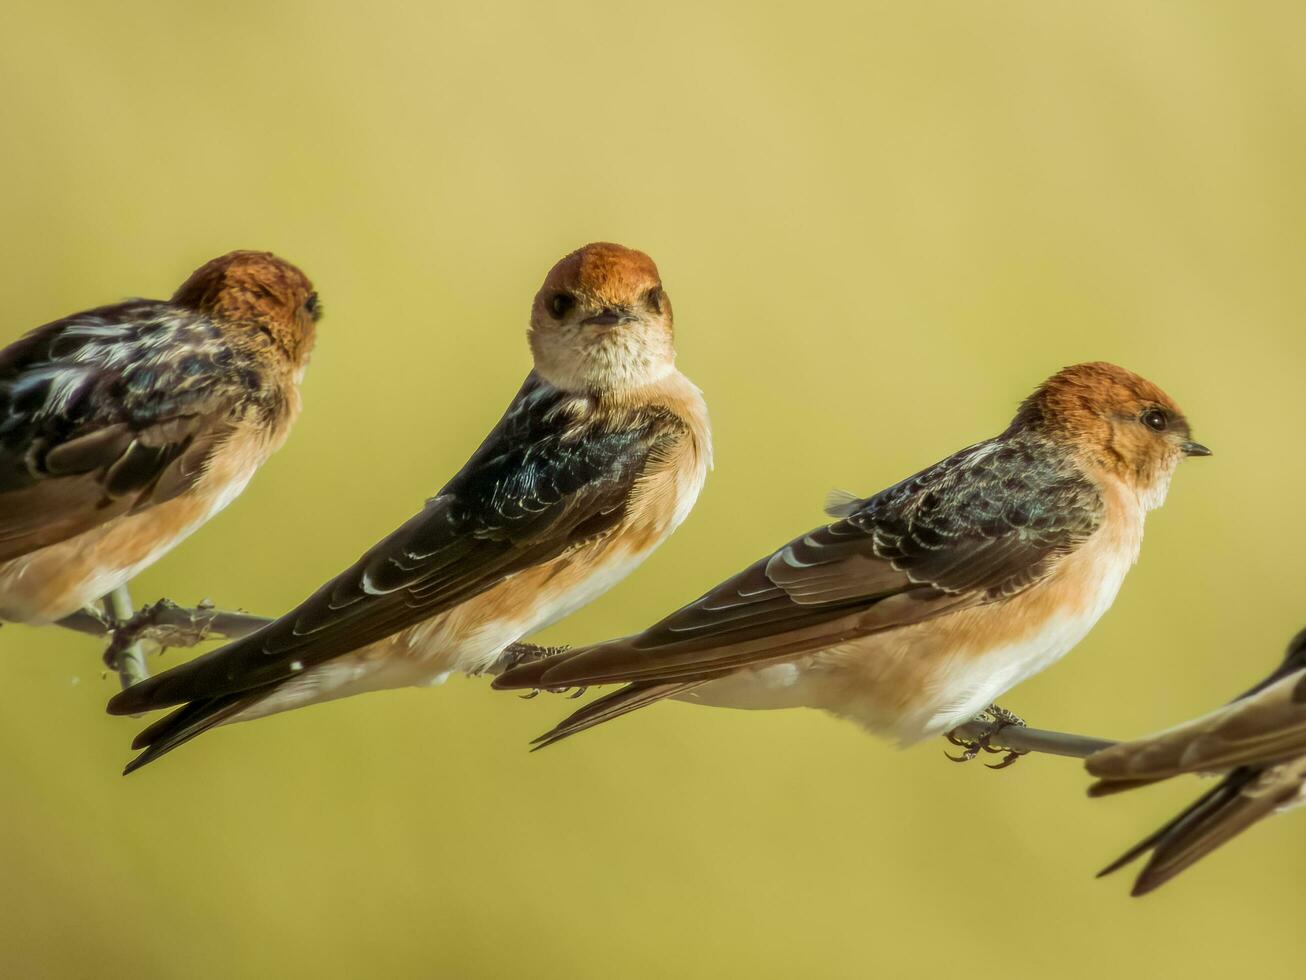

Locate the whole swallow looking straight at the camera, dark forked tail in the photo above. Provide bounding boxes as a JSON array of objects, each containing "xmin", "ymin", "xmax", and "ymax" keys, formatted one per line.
[{"xmin": 108, "ymin": 242, "xmax": 712, "ymax": 772}]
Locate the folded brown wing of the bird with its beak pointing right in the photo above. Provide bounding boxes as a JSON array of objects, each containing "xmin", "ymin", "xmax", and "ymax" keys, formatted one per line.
[{"xmin": 495, "ymin": 439, "xmax": 1102, "ymax": 738}]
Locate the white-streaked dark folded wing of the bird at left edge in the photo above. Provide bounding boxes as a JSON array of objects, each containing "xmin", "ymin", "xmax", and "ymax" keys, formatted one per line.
[{"xmin": 0, "ymin": 301, "xmax": 266, "ymax": 561}]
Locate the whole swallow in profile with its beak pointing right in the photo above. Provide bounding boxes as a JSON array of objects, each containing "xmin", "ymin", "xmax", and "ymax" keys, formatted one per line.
[{"xmin": 494, "ymin": 362, "xmax": 1211, "ymax": 758}]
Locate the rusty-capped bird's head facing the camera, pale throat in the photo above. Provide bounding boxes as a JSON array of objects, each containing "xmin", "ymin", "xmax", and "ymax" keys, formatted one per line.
[{"xmin": 530, "ymin": 242, "xmax": 675, "ymax": 393}]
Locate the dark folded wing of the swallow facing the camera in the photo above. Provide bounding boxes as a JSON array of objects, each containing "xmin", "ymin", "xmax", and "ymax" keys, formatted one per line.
[{"xmin": 110, "ymin": 375, "xmax": 680, "ymax": 713}]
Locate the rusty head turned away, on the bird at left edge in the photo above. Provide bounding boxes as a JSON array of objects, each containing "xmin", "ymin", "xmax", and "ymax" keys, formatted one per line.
[{"xmin": 172, "ymin": 252, "xmax": 323, "ymax": 367}]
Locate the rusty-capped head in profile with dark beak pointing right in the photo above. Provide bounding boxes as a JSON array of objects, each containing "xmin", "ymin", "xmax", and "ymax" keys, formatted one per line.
[{"xmin": 1012, "ymin": 361, "xmax": 1211, "ymax": 508}]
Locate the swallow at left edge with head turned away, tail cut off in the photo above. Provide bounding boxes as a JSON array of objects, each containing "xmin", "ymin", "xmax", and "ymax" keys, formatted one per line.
[{"xmin": 0, "ymin": 252, "xmax": 321, "ymax": 625}]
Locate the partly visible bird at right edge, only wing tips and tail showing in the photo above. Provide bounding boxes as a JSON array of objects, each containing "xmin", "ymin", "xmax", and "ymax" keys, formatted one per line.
[{"xmin": 1084, "ymin": 630, "xmax": 1306, "ymax": 895}]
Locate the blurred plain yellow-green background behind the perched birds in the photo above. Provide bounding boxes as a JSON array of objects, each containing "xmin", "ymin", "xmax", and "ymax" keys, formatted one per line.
[{"xmin": 0, "ymin": 0, "xmax": 1306, "ymax": 979}]
